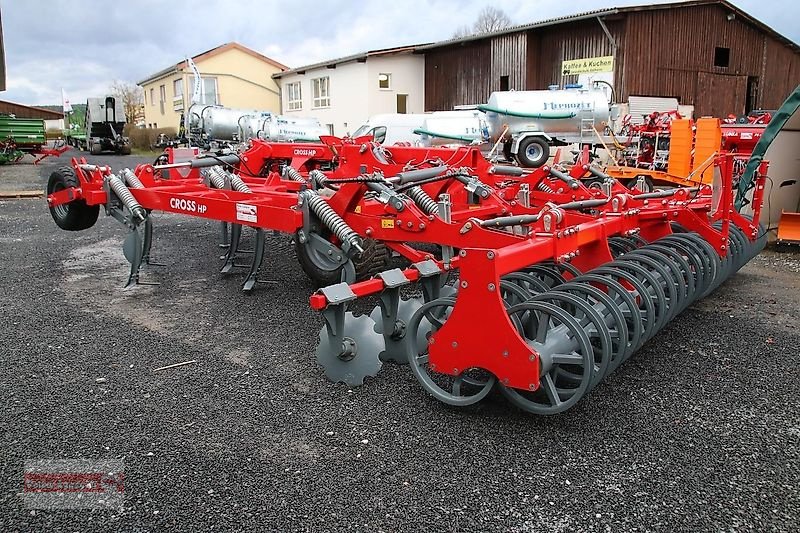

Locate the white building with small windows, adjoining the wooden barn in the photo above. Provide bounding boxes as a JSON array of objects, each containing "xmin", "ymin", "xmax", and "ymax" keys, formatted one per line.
[{"xmin": 272, "ymin": 46, "xmax": 425, "ymax": 136}]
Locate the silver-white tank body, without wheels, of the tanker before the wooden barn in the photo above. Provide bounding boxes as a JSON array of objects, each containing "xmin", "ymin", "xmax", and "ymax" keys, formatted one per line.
[{"xmin": 478, "ymin": 89, "xmax": 609, "ymax": 140}]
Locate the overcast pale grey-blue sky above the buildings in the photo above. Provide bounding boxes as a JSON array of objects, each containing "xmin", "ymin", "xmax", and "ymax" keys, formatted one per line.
[{"xmin": 0, "ymin": 0, "xmax": 800, "ymax": 104}]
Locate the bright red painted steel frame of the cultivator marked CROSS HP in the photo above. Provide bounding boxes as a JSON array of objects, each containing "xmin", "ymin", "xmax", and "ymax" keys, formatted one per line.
[{"xmin": 48, "ymin": 142, "xmax": 766, "ymax": 390}]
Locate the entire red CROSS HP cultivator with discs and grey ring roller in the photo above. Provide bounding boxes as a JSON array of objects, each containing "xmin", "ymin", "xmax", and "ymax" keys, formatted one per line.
[{"xmin": 48, "ymin": 138, "xmax": 766, "ymax": 414}]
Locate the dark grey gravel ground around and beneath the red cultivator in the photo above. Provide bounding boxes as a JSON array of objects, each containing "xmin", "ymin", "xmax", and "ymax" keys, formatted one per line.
[{"xmin": 0, "ymin": 153, "xmax": 800, "ymax": 531}]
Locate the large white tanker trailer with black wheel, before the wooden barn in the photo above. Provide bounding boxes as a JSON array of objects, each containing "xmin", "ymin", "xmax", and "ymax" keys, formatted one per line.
[{"xmin": 478, "ymin": 88, "xmax": 618, "ymax": 167}]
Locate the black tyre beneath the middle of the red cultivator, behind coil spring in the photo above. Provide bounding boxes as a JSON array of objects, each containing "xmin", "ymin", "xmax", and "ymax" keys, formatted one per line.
[{"xmin": 295, "ymin": 238, "xmax": 391, "ymax": 287}]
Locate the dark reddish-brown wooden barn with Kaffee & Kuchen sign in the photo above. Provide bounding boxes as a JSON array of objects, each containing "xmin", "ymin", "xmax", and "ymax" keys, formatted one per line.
[{"xmin": 418, "ymin": 0, "xmax": 800, "ymax": 117}]
